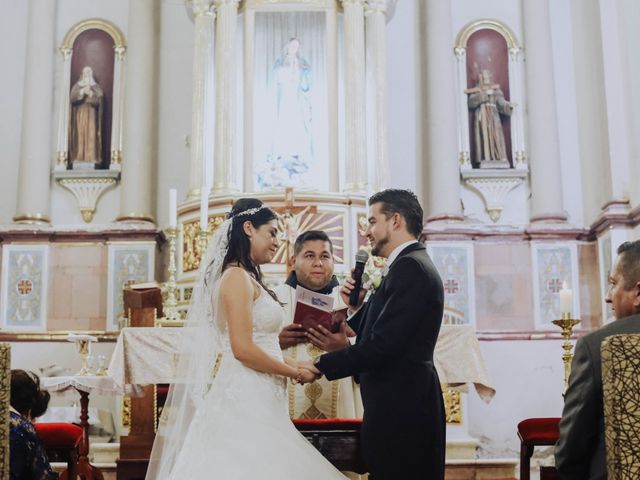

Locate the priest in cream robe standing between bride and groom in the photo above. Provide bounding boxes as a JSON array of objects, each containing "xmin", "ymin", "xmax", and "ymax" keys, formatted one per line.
[{"xmin": 276, "ymin": 230, "xmax": 362, "ymax": 419}]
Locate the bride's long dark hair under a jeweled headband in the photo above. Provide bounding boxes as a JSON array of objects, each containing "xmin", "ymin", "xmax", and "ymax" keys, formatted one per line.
[{"xmin": 222, "ymin": 198, "xmax": 278, "ymax": 301}]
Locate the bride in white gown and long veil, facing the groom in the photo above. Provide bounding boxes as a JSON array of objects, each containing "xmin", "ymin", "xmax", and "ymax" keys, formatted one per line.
[{"xmin": 146, "ymin": 198, "xmax": 345, "ymax": 480}]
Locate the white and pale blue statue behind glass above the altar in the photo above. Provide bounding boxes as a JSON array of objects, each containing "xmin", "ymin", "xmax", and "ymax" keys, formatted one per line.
[{"xmin": 258, "ymin": 38, "xmax": 313, "ymax": 188}]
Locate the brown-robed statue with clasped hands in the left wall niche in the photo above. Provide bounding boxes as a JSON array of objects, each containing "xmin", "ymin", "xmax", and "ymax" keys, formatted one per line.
[{"xmin": 69, "ymin": 67, "xmax": 104, "ymax": 170}]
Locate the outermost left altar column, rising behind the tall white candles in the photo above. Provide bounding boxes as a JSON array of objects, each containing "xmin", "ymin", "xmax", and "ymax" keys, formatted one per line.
[{"xmin": 188, "ymin": 0, "xmax": 215, "ymax": 199}]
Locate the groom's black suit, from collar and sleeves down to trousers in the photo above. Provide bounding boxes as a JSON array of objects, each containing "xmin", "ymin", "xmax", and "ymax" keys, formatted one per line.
[{"xmin": 316, "ymin": 243, "xmax": 445, "ymax": 480}]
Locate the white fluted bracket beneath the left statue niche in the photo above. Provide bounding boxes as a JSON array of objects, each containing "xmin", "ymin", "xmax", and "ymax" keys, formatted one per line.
[{"xmin": 53, "ymin": 170, "xmax": 120, "ymax": 223}]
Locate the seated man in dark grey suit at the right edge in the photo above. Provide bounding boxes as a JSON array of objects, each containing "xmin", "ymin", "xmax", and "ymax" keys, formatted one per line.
[{"xmin": 555, "ymin": 240, "xmax": 640, "ymax": 480}]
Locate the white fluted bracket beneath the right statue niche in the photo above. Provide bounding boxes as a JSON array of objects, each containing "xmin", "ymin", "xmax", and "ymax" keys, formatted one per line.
[{"xmin": 460, "ymin": 169, "xmax": 527, "ymax": 223}]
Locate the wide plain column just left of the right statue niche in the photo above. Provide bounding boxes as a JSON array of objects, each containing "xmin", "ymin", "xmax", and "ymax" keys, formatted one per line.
[{"xmin": 417, "ymin": 0, "xmax": 463, "ymax": 222}]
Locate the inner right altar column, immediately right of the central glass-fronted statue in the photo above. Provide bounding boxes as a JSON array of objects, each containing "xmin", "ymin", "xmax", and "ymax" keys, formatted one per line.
[{"xmin": 342, "ymin": 0, "xmax": 367, "ymax": 192}]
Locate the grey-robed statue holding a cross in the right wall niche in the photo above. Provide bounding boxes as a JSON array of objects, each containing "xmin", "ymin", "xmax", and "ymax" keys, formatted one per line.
[{"xmin": 465, "ymin": 69, "xmax": 513, "ymax": 168}]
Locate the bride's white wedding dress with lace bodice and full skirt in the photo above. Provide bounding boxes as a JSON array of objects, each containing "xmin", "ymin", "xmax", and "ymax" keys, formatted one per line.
[{"xmin": 165, "ymin": 289, "xmax": 345, "ymax": 480}]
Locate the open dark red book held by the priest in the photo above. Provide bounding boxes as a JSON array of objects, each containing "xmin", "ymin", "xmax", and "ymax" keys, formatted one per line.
[{"xmin": 293, "ymin": 285, "xmax": 347, "ymax": 333}]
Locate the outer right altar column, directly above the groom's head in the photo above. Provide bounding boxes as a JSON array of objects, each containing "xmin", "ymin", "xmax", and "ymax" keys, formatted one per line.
[{"xmin": 366, "ymin": 0, "xmax": 389, "ymax": 191}]
